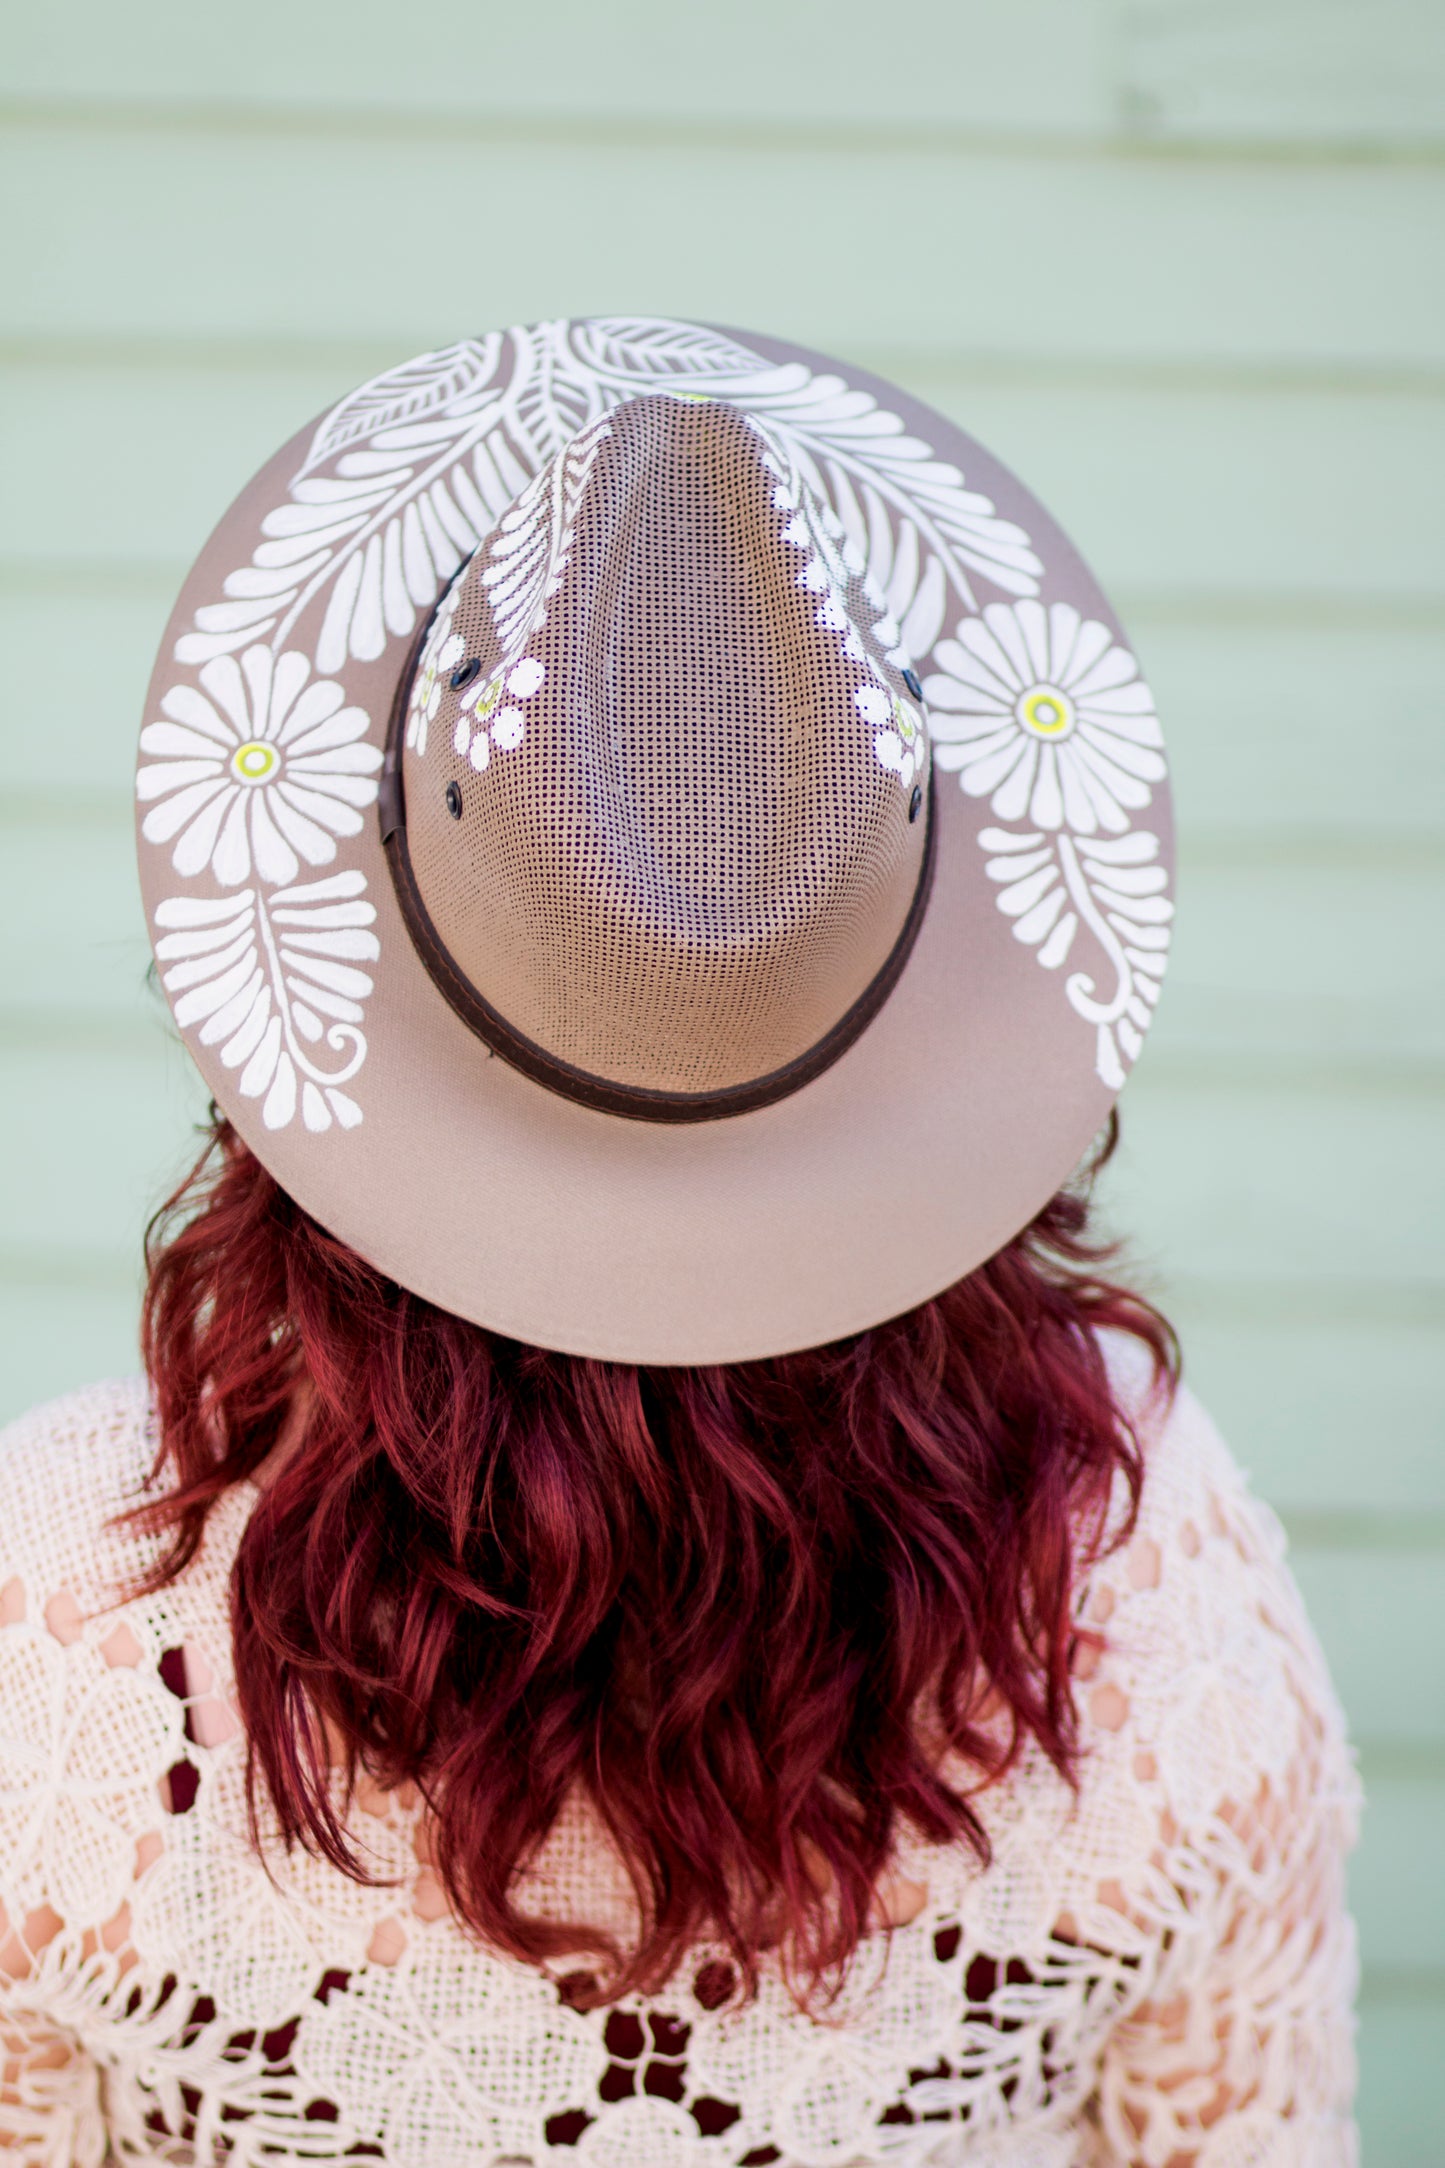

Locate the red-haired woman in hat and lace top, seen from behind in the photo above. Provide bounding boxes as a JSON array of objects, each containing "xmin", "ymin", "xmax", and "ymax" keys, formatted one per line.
[{"xmin": 0, "ymin": 319, "xmax": 1356, "ymax": 2168}]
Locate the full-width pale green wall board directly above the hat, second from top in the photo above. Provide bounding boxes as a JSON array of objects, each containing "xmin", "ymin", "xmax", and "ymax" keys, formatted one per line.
[{"xmin": 0, "ymin": 113, "xmax": 1445, "ymax": 368}]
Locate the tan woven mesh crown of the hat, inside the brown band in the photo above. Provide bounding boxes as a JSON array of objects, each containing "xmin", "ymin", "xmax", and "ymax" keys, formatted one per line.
[{"xmin": 403, "ymin": 395, "xmax": 929, "ymax": 1097}]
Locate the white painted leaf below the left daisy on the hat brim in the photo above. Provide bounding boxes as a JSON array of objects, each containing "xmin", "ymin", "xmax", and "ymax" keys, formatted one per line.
[{"xmin": 156, "ymin": 872, "xmax": 381, "ymax": 1132}]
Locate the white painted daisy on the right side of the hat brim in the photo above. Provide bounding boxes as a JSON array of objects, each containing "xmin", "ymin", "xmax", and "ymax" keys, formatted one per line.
[{"xmin": 923, "ymin": 601, "xmax": 1166, "ymax": 835}]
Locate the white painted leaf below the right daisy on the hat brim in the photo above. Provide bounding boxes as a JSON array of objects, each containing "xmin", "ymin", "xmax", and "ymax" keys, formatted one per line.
[{"xmin": 979, "ymin": 828, "xmax": 1174, "ymax": 1091}]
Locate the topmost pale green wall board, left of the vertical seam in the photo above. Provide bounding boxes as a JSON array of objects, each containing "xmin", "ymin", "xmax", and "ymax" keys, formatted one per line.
[{"xmin": 2, "ymin": 0, "xmax": 1114, "ymax": 145}]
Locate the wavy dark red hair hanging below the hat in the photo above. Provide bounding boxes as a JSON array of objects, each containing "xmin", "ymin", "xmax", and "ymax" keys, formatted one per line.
[{"xmin": 141, "ymin": 1121, "xmax": 1179, "ymax": 1999}]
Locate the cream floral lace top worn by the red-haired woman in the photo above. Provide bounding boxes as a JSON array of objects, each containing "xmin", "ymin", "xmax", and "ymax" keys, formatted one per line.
[{"xmin": 0, "ymin": 1381, "xmax": 1356, "ymax": 2168}]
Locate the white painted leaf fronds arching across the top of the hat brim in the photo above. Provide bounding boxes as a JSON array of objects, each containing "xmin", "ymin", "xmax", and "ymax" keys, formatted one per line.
[{"xmin": 175, "ymin": 317, "xmax": 1042, "ymax": 672}]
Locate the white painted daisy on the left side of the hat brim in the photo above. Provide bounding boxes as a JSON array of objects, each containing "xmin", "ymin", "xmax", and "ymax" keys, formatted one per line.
[{"xmin": 136, "ymin": 646, "xmax": 381, "ymax": 887}]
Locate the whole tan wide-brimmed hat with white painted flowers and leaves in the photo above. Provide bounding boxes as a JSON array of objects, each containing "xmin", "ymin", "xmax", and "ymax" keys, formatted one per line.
[{"xmin": 136, "ymin": 317, "xmax": 1172, "ymax": 1364}]
